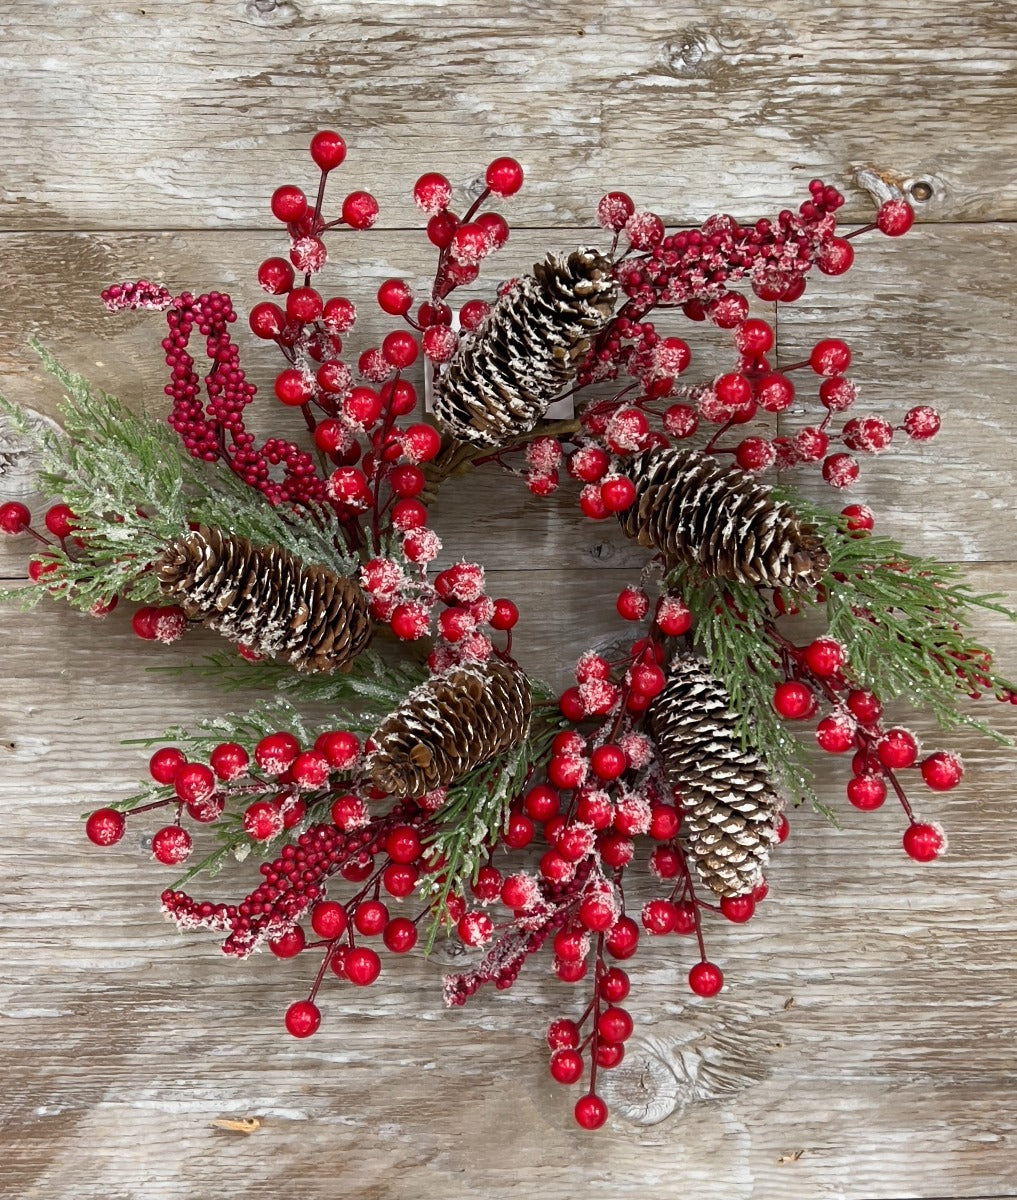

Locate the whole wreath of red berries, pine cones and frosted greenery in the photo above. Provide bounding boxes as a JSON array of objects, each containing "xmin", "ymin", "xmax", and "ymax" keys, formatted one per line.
[{"xmin": 0, "ymin": 131, "xmax": 1017, "ymax": 1129}]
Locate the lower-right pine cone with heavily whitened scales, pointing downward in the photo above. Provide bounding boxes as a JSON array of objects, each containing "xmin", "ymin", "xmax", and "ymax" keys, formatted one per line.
[{"xmin": 648, "ymin": 656, "xmax": 781, "ymax": 896}]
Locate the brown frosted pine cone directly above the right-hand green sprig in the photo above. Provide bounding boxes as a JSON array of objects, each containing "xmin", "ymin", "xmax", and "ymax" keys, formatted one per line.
[{"xmin": 620, "ymin": 446, "xmax": 830, "ymax": 590}]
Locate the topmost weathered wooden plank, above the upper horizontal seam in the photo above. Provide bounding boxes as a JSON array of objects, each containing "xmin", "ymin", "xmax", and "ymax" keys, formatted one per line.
[{"xmin": 0, "ymin": 0, "xmax": 1017, "ymax": 230}]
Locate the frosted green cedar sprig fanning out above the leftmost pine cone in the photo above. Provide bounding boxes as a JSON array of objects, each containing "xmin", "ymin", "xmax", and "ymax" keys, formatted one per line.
[{"xmin": 0, "ymin": 346, "xmax": 355, "ymax": 610}]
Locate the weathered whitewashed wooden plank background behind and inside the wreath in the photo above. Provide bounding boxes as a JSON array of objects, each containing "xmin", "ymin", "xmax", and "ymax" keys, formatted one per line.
[{"xmin": 0, "ymin": 0, "xmax": 1017, "ymax": 1200}]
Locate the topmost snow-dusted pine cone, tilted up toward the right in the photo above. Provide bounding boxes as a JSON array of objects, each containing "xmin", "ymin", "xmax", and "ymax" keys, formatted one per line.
[{"xmin": 434, "ymin": 248, "xmax": 616, "ymax": 446}]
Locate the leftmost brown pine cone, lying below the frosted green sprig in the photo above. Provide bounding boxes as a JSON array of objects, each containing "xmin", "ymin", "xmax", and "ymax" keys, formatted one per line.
[{"xmin": 155, "ymin": 526, "xmax": 371, "ymax": 672}]
